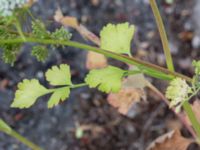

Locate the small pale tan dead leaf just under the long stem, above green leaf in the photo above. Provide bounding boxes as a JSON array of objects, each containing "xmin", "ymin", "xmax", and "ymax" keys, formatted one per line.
[{"xmin": 86, "ymin": 52, "xmax": 108, "ymax": 70}]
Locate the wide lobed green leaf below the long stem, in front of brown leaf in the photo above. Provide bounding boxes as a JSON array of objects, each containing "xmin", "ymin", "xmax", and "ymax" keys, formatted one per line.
[{"xmin": 85, "ymin": 66, "xmax": 125, "ymax": 93}]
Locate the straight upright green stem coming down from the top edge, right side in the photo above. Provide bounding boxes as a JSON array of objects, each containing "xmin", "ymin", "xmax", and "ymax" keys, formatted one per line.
[{"xmin": 150, "ymin": 0, "xmax": 174, "ymax": 71}]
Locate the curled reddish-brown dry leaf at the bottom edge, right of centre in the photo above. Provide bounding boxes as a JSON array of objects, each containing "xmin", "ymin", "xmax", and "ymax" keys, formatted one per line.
[{"xmin": 146, "ymin": 130, "xmax": 194, "ymax": 150}]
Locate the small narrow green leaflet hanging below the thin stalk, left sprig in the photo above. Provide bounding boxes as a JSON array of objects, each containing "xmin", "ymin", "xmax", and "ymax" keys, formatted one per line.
[{"xmin": 48, "ymin": 87, "xmax": 70, "ymax": 108}]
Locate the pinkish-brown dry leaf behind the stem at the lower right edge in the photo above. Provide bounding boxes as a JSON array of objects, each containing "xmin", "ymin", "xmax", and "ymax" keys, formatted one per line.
[{"xmin": 186, "ymin": 100, "xmax": 200, "ymax": 125}]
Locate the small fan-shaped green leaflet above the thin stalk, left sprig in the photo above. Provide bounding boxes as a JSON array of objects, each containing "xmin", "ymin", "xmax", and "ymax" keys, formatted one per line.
[{"xmin": 45, "ymin": 64, "xmax": 72, "ymax": 85}]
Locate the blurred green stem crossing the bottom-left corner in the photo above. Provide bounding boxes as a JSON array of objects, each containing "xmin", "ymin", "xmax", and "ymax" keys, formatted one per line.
[{"xmin": 0, "ymin": 119, "xmax": 42, "ymax": 150}]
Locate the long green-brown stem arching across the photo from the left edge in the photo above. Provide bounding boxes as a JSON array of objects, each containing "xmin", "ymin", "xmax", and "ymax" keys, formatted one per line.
[{"xmin": 0, "ymin": 37, "xmax": 192, "ymax": 82}]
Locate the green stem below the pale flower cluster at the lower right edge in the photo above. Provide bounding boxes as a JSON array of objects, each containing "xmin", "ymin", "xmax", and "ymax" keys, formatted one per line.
[{"xmin": 183, "ymin": 101, "xmax": 200, "ymax": 141}]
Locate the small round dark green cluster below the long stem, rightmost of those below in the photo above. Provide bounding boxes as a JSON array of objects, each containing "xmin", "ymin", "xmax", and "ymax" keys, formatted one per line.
[{"xmin": 31, "ymin": 45, "xmax": 48, "ymax": 62}]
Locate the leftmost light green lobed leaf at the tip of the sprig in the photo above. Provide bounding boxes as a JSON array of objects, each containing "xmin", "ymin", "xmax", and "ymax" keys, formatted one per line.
[{"xmin": 11, "ymin": 79, "xmax": 49, "ymax": 108}]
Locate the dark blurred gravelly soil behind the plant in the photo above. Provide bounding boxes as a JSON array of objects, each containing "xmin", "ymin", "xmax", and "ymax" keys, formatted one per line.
[{"xmin": 0, "ymin": 0, "xmax": 200, "ymax": 150}]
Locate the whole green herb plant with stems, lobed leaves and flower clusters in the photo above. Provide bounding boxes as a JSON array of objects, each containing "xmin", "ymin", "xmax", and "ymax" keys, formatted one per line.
[{"xmin": 0, "ymin": 0, "xmax": 200, "ymax": 149}]
